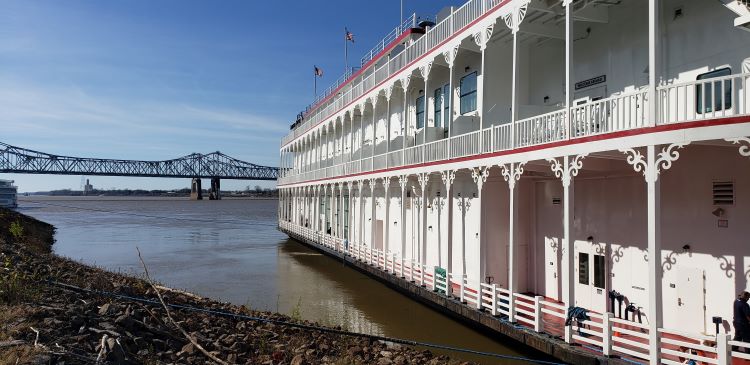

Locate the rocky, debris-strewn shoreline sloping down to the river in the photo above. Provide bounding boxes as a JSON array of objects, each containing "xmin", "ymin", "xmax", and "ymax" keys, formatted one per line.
[{"xmin": 0, "ymin": 210, "xmax": 470, "ymax": 365}]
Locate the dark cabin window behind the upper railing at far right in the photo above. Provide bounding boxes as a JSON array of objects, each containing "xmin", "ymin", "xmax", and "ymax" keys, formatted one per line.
[{"xmin": 695, "ymin": 67, "xmax": 732, "ymax": 114}]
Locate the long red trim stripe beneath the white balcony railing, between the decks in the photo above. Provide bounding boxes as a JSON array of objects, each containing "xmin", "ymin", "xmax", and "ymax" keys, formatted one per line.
[{"xmin": 278, "ymin": 116, "xmax": 750, "ymax": 187}]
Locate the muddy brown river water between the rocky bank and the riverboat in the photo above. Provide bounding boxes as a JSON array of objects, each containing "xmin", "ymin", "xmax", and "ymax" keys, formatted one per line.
[{"xmin": 14, "ymin": 196, "xmax": 539, "ymax": 364}]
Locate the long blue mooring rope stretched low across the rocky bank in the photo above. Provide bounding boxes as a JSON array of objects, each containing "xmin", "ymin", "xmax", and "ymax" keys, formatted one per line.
[{"xmin": 46, "ymin": 280, "xmax": 564, "ymax": 365}]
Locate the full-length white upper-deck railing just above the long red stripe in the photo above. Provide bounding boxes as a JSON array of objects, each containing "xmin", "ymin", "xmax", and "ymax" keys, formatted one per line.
[{"xmin": 279, "ymin": 73, "xmax": 750, "ymax": 184}]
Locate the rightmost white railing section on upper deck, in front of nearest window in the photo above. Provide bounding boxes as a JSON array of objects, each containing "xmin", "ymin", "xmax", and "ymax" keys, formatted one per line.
[{"xmin": 657, "ymin": 73, "xmax": 750, "ymax": 124}]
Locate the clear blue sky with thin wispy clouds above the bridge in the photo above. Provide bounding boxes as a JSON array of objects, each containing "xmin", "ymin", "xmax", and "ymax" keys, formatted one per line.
[{"xmin": 0, "ymin": 0, "xmax": 452, "ymax": 191}]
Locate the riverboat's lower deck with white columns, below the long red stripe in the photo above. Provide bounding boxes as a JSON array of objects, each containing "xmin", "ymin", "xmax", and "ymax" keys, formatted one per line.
[{"xmin": 280, "ymin": 120, "xmax": 750, "ymax": 364}]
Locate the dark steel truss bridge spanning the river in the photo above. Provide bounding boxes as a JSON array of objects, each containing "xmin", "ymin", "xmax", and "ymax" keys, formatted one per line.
[{"xmin": 0, "ymin": 142, "xmax": 279, "ymax": 199}]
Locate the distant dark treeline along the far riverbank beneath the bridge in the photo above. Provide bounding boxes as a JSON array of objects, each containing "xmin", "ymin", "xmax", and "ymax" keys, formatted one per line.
[{"xmin": 27, "ymin": 186, "xmax": 279, "ymax": 198}]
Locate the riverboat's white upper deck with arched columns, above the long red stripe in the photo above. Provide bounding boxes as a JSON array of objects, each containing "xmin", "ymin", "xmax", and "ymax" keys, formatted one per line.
[{"xmin": 279, "ymin": 0, "xmax": 750, "ymax": 185}]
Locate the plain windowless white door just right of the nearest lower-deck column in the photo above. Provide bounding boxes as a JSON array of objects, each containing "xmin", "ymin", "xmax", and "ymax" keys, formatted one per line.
[{"xmin": 680, "ymin": 267, "xmax": 706, "ymax": 333}]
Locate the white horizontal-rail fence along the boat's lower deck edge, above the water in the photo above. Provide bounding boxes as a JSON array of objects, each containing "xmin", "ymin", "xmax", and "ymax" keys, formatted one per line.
[{"xmin": 279, "ymin": 221, "xmax": 750, "ymax": 365}]
